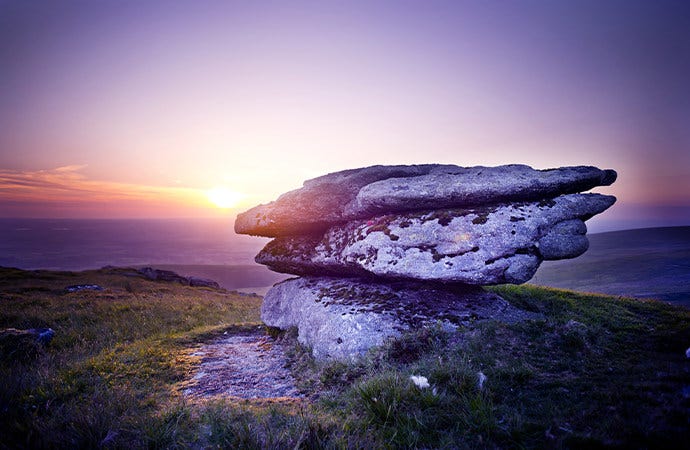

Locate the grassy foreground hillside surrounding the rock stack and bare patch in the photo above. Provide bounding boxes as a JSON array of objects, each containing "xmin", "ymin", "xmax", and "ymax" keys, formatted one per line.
[{"xmin": 0, "ymin": 269, "xmax": 690, "ymax": 448}]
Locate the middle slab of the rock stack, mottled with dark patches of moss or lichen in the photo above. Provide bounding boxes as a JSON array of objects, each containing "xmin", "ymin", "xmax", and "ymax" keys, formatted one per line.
[{"xmin": 256, "ymin": 194, "xmax": 615, "ymax": 285}]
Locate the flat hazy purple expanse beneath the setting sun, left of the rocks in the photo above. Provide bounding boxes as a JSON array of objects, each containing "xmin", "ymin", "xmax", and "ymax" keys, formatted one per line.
[{"xmin": 0, "ymin": 219, "xmax": 268, "ymax": 270}]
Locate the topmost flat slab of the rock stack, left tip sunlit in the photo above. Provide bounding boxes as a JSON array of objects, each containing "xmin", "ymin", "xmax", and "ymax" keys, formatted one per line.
[{"xmin": 235, "ymin": 164, "xmax": 616, "ymax": 237}]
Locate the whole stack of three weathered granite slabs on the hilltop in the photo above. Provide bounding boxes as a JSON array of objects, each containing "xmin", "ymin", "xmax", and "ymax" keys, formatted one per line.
[{"xmin": 235, "ymin": 164, "xmax": 616, "ymax": 358}]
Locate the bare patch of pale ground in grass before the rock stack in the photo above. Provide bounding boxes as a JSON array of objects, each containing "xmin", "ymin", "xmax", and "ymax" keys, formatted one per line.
[{"xmin": 183, "ymin": 329, "xmax": 302, "ymax": 399}]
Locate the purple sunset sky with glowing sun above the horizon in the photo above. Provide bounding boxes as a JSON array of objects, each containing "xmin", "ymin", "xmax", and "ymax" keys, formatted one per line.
[{"xmin": 0, "ymin": 0, "xmax": 690, "ymax": 231}]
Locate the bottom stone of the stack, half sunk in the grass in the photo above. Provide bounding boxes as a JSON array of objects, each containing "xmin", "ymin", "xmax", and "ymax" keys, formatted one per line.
[{"xmin": 261, "ymin": 277, "xmax": 535, "ymax": 360}]
